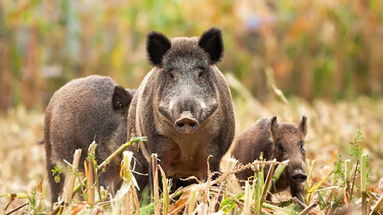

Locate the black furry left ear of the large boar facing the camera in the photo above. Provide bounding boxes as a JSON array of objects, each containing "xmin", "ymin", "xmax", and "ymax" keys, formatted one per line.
[{"xmin": 146, "ymin": 32, "xmax": 171, "ymax": 67}]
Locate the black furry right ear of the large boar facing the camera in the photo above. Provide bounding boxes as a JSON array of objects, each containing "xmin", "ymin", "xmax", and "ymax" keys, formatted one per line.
[{"xmin": 198, "ymin": 28, "xmax": 223, "ymax": 64}]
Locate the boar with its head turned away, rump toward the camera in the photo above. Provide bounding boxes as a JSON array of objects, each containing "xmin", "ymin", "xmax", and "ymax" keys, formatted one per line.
[{"xmin": 44, "ymin": 75, "xmax": 134, "ymax": 203}]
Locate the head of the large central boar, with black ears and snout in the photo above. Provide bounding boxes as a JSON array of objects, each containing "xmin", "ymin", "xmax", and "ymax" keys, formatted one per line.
[{"xmin": 147, "ymin": 28, "xmax": 223, "ymax": 134}]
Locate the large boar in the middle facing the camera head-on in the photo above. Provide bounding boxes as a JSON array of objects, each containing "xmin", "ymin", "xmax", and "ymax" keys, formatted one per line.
[{"xmin": 128, "ymin": 28, "xmax": 235, "ymax": 191}]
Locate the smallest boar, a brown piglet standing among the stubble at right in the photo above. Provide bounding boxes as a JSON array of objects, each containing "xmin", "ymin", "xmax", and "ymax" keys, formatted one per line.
[{"xmin": 232, "ymin": 116, "xmax": 307, "ymax": 201}]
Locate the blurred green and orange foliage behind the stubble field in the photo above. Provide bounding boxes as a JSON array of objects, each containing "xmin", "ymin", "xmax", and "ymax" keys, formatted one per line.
[{"xmin": 0, "ymin": 0, "xmax": 383, "ymax": 110}]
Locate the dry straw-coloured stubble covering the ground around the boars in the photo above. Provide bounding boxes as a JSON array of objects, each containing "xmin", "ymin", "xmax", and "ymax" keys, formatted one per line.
[{"xmin": 0, "ymin": 95, "xmax": 383, "ymax": 214}]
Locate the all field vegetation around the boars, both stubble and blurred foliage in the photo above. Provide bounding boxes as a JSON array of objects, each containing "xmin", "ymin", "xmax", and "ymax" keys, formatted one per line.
[{"xmin": 0, "ymin": 0, "xmax": 383, "ymax": 215}]
